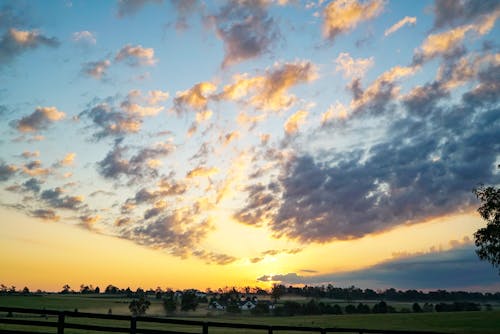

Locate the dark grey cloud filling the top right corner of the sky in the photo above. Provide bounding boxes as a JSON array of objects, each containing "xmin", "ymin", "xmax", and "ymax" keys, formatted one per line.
[{"xmin": 433, "ymin": 0, "xmax": 500, "ymax": 28}]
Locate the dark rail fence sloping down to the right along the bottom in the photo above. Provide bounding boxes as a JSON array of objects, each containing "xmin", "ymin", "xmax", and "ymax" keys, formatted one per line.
[{"xmin": 0, "ymin": 306, "xmax": 449, "ymax": 334}]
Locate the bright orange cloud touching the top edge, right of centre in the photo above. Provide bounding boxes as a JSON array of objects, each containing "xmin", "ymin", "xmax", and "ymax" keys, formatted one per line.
[{"xmin": 323, "ymin": 0, "xmax": 385, "ymax": 41}]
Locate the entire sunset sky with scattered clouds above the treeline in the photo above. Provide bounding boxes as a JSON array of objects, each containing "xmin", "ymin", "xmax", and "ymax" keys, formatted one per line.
[{"xmin": 0, "ymin": 0, "xmax": 500, "ymax": 291}]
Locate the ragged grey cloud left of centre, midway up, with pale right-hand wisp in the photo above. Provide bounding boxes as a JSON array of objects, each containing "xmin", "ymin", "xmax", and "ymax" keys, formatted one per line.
[{"xmin": 97, "ymin": 140, "xmax": 174, "ymax": 182}]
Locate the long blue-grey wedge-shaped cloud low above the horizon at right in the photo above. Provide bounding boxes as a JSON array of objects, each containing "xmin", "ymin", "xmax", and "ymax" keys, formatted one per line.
[{"xmin": 258, "ymin": 245, "xmax": 498, "ymax": 290}]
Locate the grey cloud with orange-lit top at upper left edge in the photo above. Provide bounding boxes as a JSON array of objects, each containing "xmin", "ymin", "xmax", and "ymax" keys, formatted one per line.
[{"xmin": 0, "ymin": 28, "xmax": 59, "ymax": 65}]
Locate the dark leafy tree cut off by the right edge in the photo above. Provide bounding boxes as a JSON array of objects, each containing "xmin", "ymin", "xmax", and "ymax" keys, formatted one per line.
[{"xmin": 473, "ymin": 184, "xmax": 500, "ymax": 274}]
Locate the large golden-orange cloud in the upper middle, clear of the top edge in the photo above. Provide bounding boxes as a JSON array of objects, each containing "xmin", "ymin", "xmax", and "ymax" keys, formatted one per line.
[{"xmin": 216, "ymin": 61, "xmax": 318, "ymax": 111}]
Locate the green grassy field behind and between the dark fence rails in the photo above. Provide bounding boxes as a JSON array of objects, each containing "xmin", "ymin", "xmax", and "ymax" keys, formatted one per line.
[{"xmin": 0, "ymin": 295, "xmax": 500, "ymax": 334}]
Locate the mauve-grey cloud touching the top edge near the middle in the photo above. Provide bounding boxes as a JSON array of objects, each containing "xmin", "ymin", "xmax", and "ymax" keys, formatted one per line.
[{"xmin": 209, "ymin": 0, "xmax": 279, "ymax": 68}]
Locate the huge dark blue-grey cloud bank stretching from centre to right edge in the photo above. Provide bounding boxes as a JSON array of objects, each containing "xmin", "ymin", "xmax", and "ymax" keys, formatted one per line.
[{"xmin": 235, "ymin": 61, "xmax": 500, "ymax": 243}]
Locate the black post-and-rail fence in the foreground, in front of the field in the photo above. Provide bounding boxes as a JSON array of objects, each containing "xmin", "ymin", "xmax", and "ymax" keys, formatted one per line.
[{"xmin": 0, "ymin": 307, "xmax": 452, "ymax": 334}]
